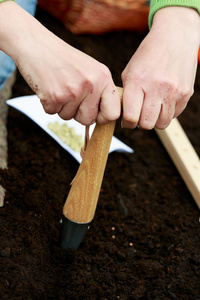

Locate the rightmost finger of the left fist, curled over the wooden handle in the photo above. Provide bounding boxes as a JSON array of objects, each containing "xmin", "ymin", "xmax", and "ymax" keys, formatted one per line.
[{"xmin": 97, "ymin": 85, "xmax": 121, "ymax": 124}]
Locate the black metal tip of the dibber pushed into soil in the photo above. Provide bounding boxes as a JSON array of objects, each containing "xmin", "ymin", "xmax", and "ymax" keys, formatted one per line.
[{"xmin": 60, "ymin": 215, "xmax": 91, "ymax": 250}]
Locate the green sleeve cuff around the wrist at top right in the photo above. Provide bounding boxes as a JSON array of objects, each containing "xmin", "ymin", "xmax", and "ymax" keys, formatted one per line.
[{"xmin": 149, "ymin": 0, "xmax": 200, "ymax": 28}]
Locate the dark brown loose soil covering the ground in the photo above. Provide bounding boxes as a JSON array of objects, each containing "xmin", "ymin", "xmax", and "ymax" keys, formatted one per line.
[{"xmin": 0, "ymin": 9, "xmax": 200, "ymax": 300}]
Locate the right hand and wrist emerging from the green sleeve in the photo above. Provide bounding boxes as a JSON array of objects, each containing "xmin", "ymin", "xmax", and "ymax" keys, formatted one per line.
[{"xmin": 122, "ymin": 7, "xmax": 200, "ymax": 129}]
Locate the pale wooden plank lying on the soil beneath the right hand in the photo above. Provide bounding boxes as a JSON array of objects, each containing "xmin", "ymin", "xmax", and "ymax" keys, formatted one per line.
[{"xmin": 155, "ymin": 118, "xmax": 200, "ymax": 209}]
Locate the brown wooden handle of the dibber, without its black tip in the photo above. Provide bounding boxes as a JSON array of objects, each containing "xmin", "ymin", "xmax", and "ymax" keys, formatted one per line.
[{"xmin": 63, "ymin": 88, "xmax": 123, "ymax": 223}]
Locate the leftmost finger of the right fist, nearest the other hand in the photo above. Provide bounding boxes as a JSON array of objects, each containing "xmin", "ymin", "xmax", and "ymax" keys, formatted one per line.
[{"xmin": 122, "ymin": 84, "xmax": 144, "ymax": 129}]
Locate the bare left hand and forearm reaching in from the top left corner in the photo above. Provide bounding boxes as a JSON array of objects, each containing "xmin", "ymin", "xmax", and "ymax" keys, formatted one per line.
[{"xmin": 0, "ymin": 1, "xmax": 121, "ymax": 125}]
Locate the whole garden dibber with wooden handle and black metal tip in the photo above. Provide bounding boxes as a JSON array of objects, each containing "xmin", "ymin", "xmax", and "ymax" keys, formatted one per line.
[{"xmin": 60, "ymin": 88, "xmax": 123, "ymax": 249}]
